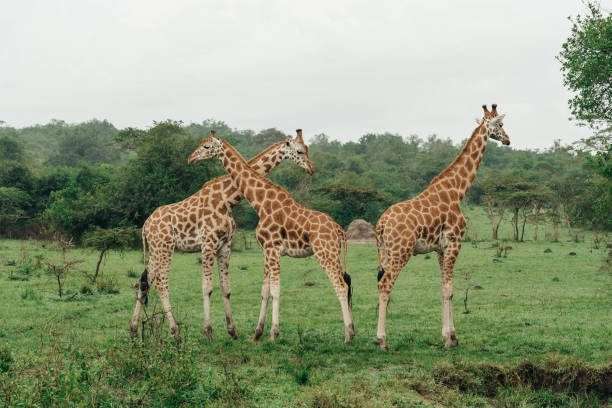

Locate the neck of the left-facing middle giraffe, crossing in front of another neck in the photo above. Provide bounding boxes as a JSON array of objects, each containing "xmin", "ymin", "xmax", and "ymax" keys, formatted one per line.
[{"xmin": 219, "ymin": 140, "xmax": 278, "ymax": 214}]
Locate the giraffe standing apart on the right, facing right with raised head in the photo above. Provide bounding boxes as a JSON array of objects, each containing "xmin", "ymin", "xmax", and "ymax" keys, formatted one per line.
[{"xmin": 376, "ymin": 104, "xmax": 510, "ymax": 350}]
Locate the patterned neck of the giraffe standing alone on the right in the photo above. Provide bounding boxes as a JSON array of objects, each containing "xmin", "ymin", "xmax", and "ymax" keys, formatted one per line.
[{"xmin": 426, "ymin": 125, "xmax": 487, "ymax": 201}]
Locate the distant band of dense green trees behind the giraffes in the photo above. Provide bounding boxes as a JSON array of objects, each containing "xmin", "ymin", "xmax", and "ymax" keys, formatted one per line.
[{"xmin": 0, "ymin": 116, "xmax": 612, "ymax": 242}]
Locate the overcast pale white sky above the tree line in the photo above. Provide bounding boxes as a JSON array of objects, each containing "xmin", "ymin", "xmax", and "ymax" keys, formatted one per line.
[{"xmin": 0, "ymin": 0, "xmax": 610, "ymax": 148}]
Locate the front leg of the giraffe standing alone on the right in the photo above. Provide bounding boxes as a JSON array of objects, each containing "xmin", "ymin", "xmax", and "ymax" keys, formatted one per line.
[{"xmin": 438, "ymin": 241, "xmax": 461, "ymax": 347}]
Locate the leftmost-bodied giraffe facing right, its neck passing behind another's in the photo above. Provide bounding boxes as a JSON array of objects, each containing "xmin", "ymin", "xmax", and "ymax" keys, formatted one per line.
[{"xmin": 130, "ymin": 131, "xmax": 314, "ymax": 339}]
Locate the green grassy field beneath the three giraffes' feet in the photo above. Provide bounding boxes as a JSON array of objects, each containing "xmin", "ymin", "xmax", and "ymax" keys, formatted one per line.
[{"xmin": 0, "ymin": 212, "xmax": 612, "ymax": 407}]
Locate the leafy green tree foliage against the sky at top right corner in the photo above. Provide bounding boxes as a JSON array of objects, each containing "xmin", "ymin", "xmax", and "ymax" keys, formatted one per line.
[{"xmin": 558, "ymin": 2, "xmax": 612, "ymax": 127}]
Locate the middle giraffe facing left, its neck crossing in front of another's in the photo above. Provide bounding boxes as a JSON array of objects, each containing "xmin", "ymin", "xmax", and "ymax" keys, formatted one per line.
[{"xmin": 189, "ymin": 129, "xmax": 355, "ymax": 343}]
